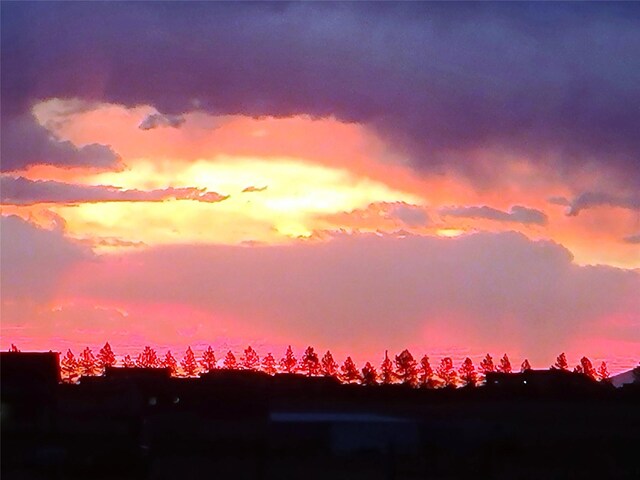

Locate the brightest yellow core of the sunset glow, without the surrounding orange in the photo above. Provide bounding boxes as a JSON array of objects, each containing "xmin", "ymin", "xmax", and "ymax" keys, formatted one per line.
[{"xmin": 50, "ymin": 156, "xmax": 421, "ymax": 251}]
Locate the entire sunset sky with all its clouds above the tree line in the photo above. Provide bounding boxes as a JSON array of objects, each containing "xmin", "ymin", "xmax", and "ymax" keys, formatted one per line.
[{"xmin": 0, "ymin": 2, "xmax": 640, "ymax": 372}]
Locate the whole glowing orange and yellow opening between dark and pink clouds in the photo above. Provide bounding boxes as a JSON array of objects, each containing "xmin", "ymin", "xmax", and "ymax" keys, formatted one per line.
[{"xmin": 8, "ymin": 99, "xmax": 640, "ymax": 268}]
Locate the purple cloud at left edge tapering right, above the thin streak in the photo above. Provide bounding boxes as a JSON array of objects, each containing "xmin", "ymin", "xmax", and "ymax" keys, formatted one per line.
[{"xmin": 0, "ymin": 113, "xmax": 118, "ymax": 172}]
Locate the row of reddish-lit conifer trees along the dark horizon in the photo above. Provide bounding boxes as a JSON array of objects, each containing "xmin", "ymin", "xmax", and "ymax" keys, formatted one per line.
[{"xmin": 13, "ymin": 343, "xmax": 609, "ymax": 388}]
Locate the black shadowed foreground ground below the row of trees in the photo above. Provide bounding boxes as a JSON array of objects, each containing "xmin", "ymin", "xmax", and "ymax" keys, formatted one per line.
[{"xmin": 1, "ymin": 355, "xmax": 640, "ymax": 480}]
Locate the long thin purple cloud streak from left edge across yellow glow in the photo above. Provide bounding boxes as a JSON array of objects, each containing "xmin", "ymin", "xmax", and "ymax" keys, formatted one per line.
[{"xmin": 0, "ymin": 176, "xmax": 229, "ymax": 205}]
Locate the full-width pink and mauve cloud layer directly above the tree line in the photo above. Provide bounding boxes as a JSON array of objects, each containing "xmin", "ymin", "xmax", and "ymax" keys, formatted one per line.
[{"xmin": 2, "ymin": 217, "xmax": 640, "ymax": 367}]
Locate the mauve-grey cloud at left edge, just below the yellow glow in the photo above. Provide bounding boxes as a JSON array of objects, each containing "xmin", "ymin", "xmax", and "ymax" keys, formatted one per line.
[{"xmin": 0, "ymin": 216, "xmax": 92, "ymax": 302}]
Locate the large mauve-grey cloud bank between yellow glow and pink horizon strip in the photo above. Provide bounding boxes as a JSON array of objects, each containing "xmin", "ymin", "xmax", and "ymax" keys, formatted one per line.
[{"xmin": 68, "ymin": 234, "xmax": 640, "ymax": 359}]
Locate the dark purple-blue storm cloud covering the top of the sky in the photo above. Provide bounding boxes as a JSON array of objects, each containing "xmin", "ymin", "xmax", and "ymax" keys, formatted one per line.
[{"xmin": 2, "ymin": 2, "xmax": 640, "ymax": 182}]
